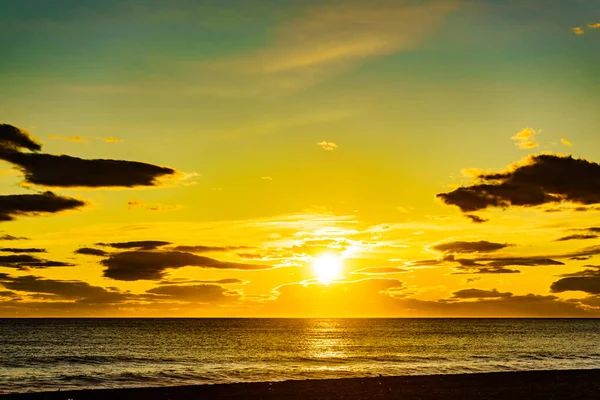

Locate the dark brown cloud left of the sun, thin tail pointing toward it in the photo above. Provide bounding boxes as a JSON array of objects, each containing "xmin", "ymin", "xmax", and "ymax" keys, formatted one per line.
[{"xmin": 101, "ymin": 251, "xmax": 272, "ymax": 281}]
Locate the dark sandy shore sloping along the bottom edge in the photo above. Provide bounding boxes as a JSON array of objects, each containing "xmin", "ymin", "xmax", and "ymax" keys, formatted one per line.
[{"xmin": 0, "ymin": 370, "xmax": 600, "ymax": 400}]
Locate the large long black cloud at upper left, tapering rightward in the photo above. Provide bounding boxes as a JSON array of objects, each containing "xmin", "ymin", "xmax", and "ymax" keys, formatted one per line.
[{"xmin": 0, "ymin": 151, "xmax": 175, "ymax": 187}]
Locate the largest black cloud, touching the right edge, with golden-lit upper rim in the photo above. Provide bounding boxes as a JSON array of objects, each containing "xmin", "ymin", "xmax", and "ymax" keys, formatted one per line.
[{"xmin": 437, "ymin": 154, "xmax": 600, "ymax": 212}]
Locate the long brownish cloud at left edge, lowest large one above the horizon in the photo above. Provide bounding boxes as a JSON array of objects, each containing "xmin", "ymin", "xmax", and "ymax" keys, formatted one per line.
[{"xmin": 0, "ymin": 274, "xmax": 130, "ymax": 303}]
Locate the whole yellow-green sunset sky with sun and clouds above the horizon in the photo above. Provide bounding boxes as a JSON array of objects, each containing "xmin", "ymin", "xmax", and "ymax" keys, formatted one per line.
[{"xmin": 0, "ymin": 0, "xmax": 600, "ymax": 317}]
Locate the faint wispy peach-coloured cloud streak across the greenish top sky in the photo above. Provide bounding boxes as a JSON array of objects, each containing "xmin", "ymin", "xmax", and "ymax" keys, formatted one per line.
[{"xmin": 202, "ymin": 0, "xmax": 461, "ymax": 93}]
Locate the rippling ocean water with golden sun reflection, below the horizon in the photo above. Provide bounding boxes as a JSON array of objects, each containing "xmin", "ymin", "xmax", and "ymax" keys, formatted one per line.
[{"xmin": 0, "ymin": 319, "xmax": 600, "ymax": 393}]
